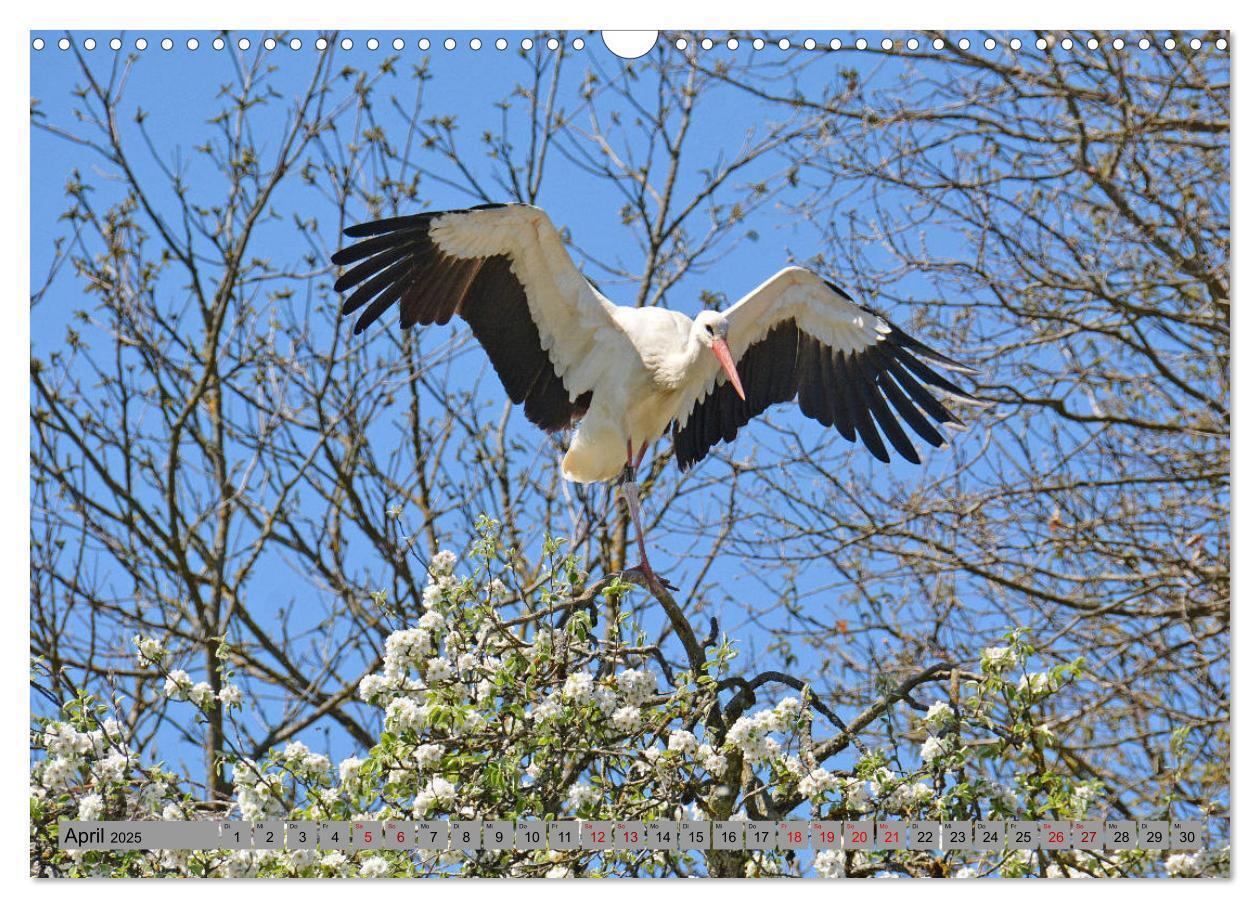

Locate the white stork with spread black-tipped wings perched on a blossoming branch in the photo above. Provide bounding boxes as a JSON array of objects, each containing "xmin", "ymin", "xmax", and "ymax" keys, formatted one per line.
[{"xmin": 333, "ymin": 205, "xmax": 979, "ymax": 583}]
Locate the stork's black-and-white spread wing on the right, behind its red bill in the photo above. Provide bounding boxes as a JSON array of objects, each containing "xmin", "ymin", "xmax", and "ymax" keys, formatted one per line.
[{"xmin": 674, "ymin": 268, "xmax": 980, "ymax": 468}]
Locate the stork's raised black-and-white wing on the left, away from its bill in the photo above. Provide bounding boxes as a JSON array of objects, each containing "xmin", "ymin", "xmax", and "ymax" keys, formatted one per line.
[{"xmin": 333, "ymin": 205, "xmax": 629, "ymax": 432}]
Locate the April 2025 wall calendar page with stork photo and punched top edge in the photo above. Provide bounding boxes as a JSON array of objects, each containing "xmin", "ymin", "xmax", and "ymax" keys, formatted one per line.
[{"xmin": 29, "ymin": 19, "xmax": 1232, "ymax": 876}]
